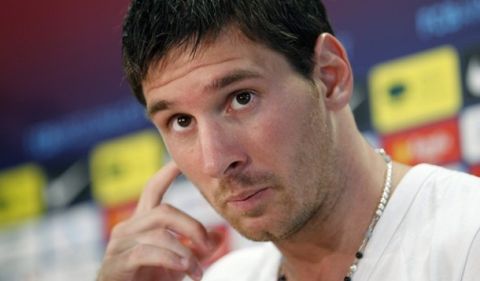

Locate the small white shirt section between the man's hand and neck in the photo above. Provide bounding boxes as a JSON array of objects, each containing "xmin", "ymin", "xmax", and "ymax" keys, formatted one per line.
[{"xmin": 202, "ymin": 242, "xmax": 281, "ymax": 281}]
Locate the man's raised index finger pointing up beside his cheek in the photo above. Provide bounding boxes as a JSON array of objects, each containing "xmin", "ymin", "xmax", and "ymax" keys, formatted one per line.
[{"xmin": 135, "ymin": 161, "xmax": 180, "ymax": 214}]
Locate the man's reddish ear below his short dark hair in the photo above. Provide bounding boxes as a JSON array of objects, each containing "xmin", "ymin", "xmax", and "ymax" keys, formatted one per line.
[{"xmin": 313, "ymin": 33, "xmax": 353, "ymax": 111}]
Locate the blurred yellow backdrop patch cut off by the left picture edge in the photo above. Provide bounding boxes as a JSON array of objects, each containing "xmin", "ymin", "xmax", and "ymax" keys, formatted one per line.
[{"xmin": 0, "ymin": 164, "xmax": 46, "ymax": 225}]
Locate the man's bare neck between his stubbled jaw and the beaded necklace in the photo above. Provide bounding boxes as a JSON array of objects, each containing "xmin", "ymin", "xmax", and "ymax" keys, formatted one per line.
[{"xmin": 275, "ymin": 137, "xmax": 404, "ymax": 281}]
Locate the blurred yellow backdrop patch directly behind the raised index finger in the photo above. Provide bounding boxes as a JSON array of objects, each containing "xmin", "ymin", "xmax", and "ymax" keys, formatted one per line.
[{"xmin": 90, "ymin": 131, "xmax": 164, "ymax": 206}]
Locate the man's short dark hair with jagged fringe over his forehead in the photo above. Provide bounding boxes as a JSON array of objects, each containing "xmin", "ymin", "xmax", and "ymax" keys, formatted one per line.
[{"xmin": 122, "ymin": 0, "xmax": 333, "ymax": 105}]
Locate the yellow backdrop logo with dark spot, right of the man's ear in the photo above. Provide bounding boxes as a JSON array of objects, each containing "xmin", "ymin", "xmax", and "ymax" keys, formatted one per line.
[{"xmin": 369, "ymin": 46, "xmax": 462, "ymax": 133}]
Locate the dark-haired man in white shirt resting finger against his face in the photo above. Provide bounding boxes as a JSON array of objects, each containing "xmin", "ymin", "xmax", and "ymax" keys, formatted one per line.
[{"xmin": 99, "ymin": 0, "xmax": 480, "ymax": 281}]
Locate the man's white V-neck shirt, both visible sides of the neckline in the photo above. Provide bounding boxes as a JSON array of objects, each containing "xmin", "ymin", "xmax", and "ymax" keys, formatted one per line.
[{"xmin": 202, "ymin": 164, "xmax": 480, "ymax": 281}]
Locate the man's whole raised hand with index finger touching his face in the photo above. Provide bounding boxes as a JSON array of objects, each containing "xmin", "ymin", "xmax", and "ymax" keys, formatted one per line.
[{"xmin": 98, "ymin": 162, "xmax": 219, "ymax": 281}]
